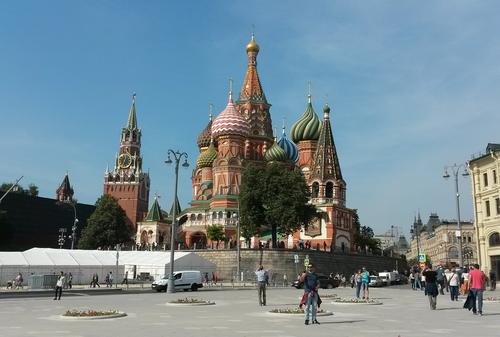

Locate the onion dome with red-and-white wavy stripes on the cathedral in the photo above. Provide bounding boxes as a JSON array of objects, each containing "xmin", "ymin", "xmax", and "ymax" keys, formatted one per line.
[{"xmin": 212, "ymin": 92, "xmax": 250, "ymax": 139}]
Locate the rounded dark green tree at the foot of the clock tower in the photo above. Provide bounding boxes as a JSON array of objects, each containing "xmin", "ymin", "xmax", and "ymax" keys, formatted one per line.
[{"xmin": 78, "ymin": 195, "xmax": 134, "ymax": 249}]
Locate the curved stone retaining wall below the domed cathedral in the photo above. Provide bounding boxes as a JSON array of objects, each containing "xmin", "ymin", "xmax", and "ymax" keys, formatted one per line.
[{"xmin": 190, "ymin": 249, "xmax": 407, "ymax": 283}]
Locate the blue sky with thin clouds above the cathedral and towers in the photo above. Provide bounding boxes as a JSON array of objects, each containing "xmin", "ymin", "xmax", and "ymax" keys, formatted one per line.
[{"xmin": 0, "ymin": 0, "xmax": 500, "ymax": 232}]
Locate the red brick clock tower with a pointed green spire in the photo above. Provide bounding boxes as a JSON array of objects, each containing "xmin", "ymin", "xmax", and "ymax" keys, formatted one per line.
[{"xmin": 104, "ymin": 94, "xmax": 150, "ymax": 231}]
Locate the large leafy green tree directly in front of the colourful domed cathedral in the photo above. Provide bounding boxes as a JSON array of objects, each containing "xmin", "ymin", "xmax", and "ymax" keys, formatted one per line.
[{"xmin": 240, "ymin": 163, "xmax": 317, "ymax": 248}]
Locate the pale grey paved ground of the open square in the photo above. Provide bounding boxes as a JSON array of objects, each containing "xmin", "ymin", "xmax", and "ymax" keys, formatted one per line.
[{"xmin": 0, "ymin": 286, "xmax": 500, "ymax": 337}]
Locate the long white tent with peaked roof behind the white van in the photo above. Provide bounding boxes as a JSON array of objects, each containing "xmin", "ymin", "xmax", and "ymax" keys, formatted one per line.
[{"xmin": 0, "ymin": 248, "xmax": 216, "ymax": 284}]
